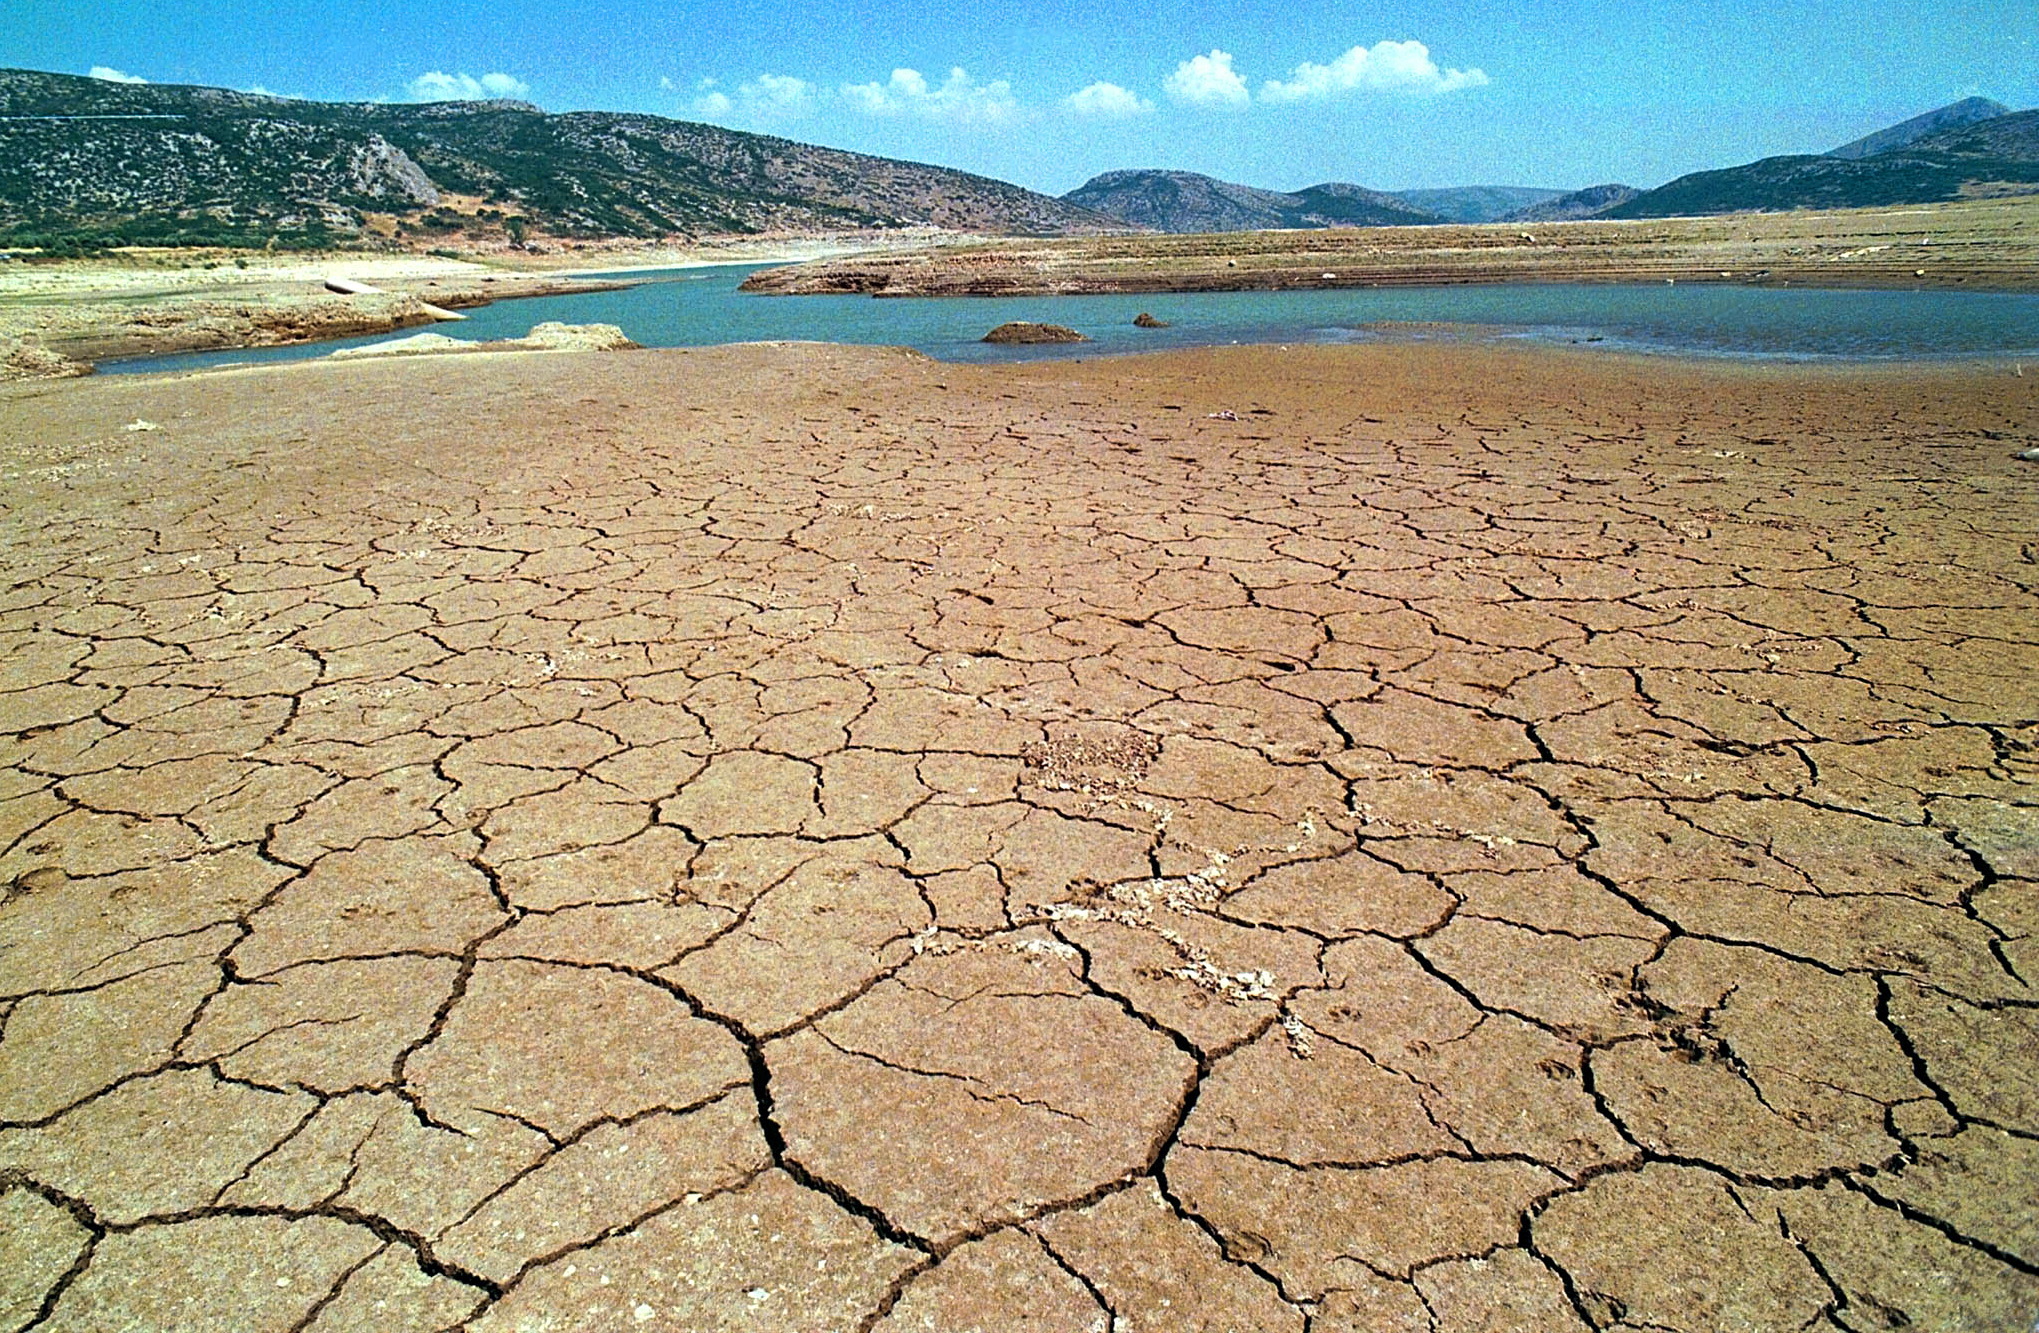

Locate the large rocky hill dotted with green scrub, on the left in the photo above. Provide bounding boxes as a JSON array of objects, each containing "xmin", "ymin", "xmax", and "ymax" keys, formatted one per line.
[{"xmin": 0, "ymin": 69, "xmax": 1117, "ymax": 245}]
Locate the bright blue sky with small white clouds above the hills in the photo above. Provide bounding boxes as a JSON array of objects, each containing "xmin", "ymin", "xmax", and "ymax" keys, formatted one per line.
[{"xmin": 0, "ymin": 0, "xmax": 2039, "ymax": 194}]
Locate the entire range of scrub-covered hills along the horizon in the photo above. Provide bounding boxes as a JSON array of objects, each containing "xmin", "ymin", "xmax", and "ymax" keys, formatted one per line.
[{"xmin": 0, "ymin": 69, "xmax": 2039, "ymax": 251}]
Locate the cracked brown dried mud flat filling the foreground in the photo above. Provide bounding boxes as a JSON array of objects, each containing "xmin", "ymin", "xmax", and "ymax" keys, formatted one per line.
[{"xmin": 0, "ymin": 346, "xmax": 2039, "ymax": 1333}]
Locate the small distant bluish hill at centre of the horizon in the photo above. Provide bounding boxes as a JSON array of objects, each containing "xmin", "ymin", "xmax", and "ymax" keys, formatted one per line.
[{"xmin": 1062, "ymin": 169, "xmax": 1442, "ymax": 232}]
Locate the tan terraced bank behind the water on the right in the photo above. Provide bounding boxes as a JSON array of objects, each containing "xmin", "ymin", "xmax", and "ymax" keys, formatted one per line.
[{"xmin": 744, "ymin": 196, "xmax": 2039, "ymax": 296}]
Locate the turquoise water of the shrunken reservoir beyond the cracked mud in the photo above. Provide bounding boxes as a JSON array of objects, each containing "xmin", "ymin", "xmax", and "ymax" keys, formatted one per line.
[{"xmin": 102, "ymin": 265, "xmax": 2039, "ymax": 371}]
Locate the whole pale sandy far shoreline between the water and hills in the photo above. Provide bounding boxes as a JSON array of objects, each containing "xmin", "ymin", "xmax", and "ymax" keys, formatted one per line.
[{"xmin": 15, "ymin": 196, "xmax": 2039, "ymax": 377}]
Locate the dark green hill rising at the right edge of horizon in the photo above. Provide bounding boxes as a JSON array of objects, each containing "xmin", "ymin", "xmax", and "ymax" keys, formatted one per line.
[{"xmin": 1601, "ymin": 110, "xmax": 2039, "ymax": 218}]
